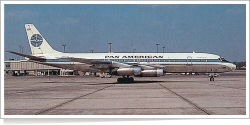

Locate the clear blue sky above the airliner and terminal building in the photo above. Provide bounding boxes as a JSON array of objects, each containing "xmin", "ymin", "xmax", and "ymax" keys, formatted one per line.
[{"xmin": 1, "ymin": 4, "xmax": 246, "ymax": 62}]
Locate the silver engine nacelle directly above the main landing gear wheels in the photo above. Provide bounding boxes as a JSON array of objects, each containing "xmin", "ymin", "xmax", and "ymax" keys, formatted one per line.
[{"xmin": 117, "ymin": 67, "xmax": 141, "ymax": 76}]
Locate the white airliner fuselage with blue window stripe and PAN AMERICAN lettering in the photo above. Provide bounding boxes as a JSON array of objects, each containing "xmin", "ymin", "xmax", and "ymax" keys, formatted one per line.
[{"xmin": 34, "ymin": 53, "xmax": 236, "ymax": 73}]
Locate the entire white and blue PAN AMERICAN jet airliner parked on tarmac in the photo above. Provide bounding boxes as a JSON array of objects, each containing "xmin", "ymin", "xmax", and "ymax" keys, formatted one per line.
[{"xmin": 7, "ymin": 24, "xmax": 236, "ymax": 83}]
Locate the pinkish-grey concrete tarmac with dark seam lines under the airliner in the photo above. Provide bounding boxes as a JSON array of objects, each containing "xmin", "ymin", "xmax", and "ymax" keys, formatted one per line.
[{"xmin": 4, "ymin": 72, "xmax": 246, "ymax": 116}]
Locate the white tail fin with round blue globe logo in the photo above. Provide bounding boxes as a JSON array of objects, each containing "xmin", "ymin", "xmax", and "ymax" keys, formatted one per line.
[{"xmin": 25, "ymin": 24, "xmax": 60, "ymax": 55}]
